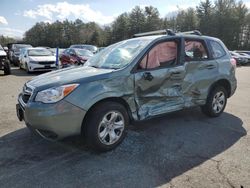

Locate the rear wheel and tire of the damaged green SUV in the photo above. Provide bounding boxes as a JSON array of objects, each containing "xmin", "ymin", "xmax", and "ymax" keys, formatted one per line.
[{"xmin": 201, "ymin": 86, "xmax": 227, "ymax": 117}]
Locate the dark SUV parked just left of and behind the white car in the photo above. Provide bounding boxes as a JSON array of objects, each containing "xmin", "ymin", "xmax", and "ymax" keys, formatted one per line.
[{"xmin": 8, "ymin": 43, "xmax": 32, "ymax": 66}]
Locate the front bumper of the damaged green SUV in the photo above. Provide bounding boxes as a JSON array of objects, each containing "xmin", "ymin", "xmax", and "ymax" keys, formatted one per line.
[{"xmin": 17, "ymin": 95, "xmax": 86, "ymax": 140}]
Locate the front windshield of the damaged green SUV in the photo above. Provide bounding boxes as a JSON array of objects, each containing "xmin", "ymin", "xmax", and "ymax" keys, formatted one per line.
[{"xmin": 84, "ymin": 38, "xmax": 152, "ymax": 69}]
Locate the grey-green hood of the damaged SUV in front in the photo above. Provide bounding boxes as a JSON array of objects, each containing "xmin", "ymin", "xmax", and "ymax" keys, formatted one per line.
[{"xmin": 28, "ymin": 67, "xmax": 113, "ymax": 90}]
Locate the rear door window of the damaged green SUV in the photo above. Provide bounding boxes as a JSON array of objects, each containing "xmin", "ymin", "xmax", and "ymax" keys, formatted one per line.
[{"xmin": 185, "ymin": 41, "xmax": 208, "ymax": 61}]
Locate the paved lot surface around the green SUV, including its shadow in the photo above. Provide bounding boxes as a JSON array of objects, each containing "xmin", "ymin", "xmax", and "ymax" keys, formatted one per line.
[{"xmin": 0, "ymin": 67, "xmax": 250, "ymax": 188}]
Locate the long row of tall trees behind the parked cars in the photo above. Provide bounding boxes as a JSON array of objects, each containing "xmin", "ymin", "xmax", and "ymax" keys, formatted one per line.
[{"xmin": 22, "ymin": 3, "xmax": 250, "ymax": 49}]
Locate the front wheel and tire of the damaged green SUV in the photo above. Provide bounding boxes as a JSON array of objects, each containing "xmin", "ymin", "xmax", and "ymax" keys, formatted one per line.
[{"xmin": 83, "ymin": 102, "xmax": 129, "ymax": 152}]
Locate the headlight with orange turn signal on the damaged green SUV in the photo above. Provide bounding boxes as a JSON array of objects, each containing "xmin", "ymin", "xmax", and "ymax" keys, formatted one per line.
[{"xmin": 35, "ymin": 84, "xmax": 79, "ymax": 103}]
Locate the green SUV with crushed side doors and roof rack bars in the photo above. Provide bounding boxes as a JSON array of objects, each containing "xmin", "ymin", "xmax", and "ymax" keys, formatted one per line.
[{"xmin": 16, "ymin": 30, "xmax": 237, "ymax": 151}]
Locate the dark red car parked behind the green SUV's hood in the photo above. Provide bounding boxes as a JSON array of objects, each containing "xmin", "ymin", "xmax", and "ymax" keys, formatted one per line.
[{"xmin": 60, "ymin": 48, "xmax": 94, "ymax": 68}]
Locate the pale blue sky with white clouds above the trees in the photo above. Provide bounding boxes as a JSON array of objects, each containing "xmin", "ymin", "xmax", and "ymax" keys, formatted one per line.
[{"xmin": 0, "ymin": 0, "xmax": 250, "ymax": 38}]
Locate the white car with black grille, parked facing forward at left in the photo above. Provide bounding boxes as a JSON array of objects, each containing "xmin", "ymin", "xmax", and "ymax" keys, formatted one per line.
[{"xmin": 20, "ymin": 48, "xmax": 56, "ymax": 73}]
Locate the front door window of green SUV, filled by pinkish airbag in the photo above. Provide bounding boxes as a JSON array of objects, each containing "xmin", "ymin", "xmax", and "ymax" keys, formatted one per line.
[{"xmin": 140, "ymin": 41, "xmax": 177, "ymax": 69}]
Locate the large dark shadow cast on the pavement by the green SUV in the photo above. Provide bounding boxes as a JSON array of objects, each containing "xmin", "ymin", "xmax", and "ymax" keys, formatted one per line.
[{"xmin": 0, "ymin": 108, "xmax": 246, "ymax": 187}]
